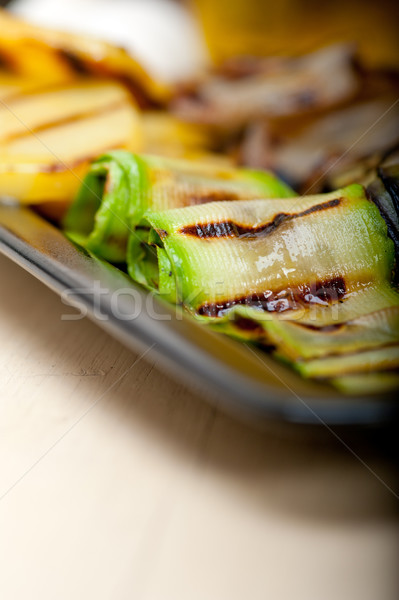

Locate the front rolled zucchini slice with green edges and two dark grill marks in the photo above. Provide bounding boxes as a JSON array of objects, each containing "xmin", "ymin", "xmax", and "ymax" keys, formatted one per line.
[{"xmin": 134, "ymin": 185, "xmax": 393, "ymax": 310}]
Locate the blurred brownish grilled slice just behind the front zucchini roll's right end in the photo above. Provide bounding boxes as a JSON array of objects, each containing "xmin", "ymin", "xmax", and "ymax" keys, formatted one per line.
[{"xmin": 241, "ymin": 98, "xmax": 399, "ymax": 193}]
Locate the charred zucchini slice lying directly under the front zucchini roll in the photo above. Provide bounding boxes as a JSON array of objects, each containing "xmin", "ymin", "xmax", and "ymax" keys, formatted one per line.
[{"xmin": 214, "ymin": 300, "xmax": 399, "ymax": 361}]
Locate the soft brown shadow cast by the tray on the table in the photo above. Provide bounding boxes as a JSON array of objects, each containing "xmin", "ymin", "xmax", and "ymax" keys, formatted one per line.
[{"xmin": 0, "ymin": 257, "xmax": 399, "ymax": 522}]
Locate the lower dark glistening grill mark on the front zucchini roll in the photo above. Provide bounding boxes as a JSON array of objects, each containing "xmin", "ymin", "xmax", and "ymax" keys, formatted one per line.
[{"xmin": 197, "ymin": 277, "xmax": 346, "ymax": 317}]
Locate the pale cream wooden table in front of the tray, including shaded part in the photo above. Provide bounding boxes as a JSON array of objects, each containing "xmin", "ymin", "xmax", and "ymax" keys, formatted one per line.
[{"xmin": 0, "ymin": 256, "xmax": 399, "ymax": 600}]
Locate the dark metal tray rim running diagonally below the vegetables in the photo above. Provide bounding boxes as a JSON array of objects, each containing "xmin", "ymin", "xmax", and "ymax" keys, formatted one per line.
[{"xmin": 0, "ymin": 205, "xmax": 398, "ymax": 425}]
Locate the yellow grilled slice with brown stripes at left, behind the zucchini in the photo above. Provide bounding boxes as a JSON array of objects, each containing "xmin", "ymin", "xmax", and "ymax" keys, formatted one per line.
[{"xmin": 0, "ymin": 81, "xmax": 142, "ymax": 203}]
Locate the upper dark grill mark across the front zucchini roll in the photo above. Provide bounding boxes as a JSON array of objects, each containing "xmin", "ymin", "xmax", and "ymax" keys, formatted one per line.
[{"xmin": 179, "ymin": 198, "xmax": 342, "ymax": 238}]
